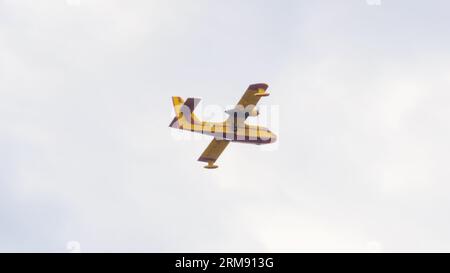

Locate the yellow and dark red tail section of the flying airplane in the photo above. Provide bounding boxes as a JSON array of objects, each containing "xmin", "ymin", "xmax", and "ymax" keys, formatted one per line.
[{"xmin": 169, "ymin": 97, "xmax": 202, "ymax": 130}]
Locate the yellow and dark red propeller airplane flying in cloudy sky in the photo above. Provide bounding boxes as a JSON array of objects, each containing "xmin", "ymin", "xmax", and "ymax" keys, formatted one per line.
[{"xmin": 169, "ymin": 83, "xmax": 277, "ymax": 169}]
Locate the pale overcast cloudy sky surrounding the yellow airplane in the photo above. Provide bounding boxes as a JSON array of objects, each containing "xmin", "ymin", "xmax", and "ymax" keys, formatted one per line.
[{"xmin": 0, "ymin": 0, "xmax": 450, "ymax": 252}]
